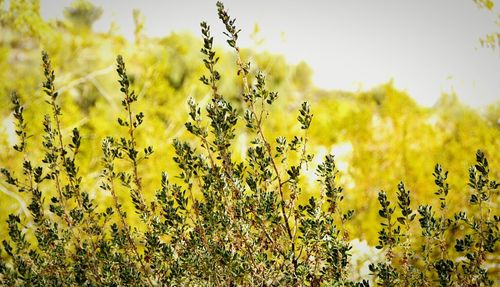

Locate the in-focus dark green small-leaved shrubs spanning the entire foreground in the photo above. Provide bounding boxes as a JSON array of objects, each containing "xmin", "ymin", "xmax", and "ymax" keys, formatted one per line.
[{"xmin": 0, "ymin": 3, "xmax": 499, "ymax": 286}]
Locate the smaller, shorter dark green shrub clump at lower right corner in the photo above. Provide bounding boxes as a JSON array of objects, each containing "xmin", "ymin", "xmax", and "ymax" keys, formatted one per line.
[{"xmin": 370, "ymin": 156, "xmax": 500, "ymax": 286}]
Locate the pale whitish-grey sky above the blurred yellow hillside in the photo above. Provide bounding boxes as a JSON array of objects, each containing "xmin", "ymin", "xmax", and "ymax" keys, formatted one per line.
[{"xmin": 41, "ymin": 0, "xmax": 500, "ymax": 107}]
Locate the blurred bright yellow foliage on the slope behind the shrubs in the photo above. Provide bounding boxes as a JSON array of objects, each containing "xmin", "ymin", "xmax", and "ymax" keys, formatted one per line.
[{"xmin": 0, "ymin": 0, "xmax": 500, "ymax": 248}]
